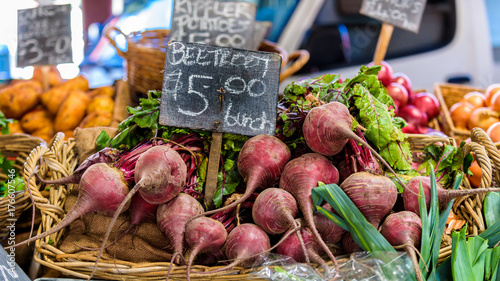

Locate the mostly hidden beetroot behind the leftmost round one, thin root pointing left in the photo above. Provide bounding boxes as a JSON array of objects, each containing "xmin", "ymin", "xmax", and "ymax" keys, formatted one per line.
[{"xmin": 35, "ymin": 147, "xmax": 120, "ymax": 184}]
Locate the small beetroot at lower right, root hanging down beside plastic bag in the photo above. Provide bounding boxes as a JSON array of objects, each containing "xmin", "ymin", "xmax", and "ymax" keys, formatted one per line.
[{"xmin": 380, "ymin": 211, "xmax": 423, "ymax": 281}]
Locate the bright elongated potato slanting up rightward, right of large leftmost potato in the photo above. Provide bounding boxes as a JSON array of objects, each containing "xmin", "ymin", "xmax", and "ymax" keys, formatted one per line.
[{"xmin": 41, "ymin": 76, "xmax": 89, "ymax": 115}]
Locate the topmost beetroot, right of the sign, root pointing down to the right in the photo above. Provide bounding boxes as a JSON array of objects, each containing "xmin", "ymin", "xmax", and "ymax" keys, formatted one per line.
[{"xmin": 302, "ymin": 102, "xmax": 405, "ymax": 186}]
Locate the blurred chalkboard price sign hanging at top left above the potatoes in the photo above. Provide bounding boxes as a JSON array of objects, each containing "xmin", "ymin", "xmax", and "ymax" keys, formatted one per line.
[{"xmin": 17, "ymin": 4, "xmax": 73, "ymax": 67}]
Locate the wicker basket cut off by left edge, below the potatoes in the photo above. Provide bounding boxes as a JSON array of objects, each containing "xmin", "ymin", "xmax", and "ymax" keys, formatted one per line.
[{"xmin": 0, "ymin": 134, "xmax": 45, "ymax": 237}]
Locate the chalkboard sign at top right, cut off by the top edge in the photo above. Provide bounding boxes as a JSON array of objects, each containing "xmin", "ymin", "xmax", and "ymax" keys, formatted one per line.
[{"xmin": 360, "ymin": 0, "xmax": 426, "ymax": 33}]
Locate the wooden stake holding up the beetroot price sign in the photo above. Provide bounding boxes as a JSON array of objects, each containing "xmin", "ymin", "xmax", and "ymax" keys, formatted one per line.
[{"xmin": 205, "ymin": 132, "xmax": 222, "ymax": 208}]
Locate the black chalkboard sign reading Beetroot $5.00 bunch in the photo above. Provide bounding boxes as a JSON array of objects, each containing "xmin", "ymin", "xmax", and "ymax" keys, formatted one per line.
[{"xmin": 160, "ymin": 41, "xmax": 281, "ymax": 136}]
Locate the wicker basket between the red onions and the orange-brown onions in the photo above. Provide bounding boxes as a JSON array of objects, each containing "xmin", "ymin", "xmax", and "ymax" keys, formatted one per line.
[{"xmin": 434, "ymin": 83, "xmax": 484, "ymax": 143}]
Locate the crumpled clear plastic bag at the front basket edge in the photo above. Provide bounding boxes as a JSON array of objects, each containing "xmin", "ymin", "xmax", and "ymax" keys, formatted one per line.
[{"xmin": 250, "ymin": 252, "xmax": 415, "ymax": 281}]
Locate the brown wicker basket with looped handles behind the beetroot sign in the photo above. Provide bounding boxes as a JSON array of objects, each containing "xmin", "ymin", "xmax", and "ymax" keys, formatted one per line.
[{"xmin": 105, "ymin": 27, "xmax": 309, "ymax": 93}]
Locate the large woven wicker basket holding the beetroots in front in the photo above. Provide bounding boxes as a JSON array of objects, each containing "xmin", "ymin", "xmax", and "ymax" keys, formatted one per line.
[{"xmin": 25, "ymin": 132, "xmax": 491, "ymax": 281}]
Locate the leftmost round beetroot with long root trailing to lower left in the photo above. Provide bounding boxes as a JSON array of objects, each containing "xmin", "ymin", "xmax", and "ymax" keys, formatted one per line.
[{"xmin": 9, "ymin": 163, "xmax": 130, "ymax": 247}]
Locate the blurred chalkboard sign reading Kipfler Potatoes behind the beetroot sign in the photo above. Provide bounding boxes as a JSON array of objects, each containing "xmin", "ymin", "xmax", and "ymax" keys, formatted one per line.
[{"xmin": 170, "ymin": 0, "xmax": 257, "ymax": 49}]
